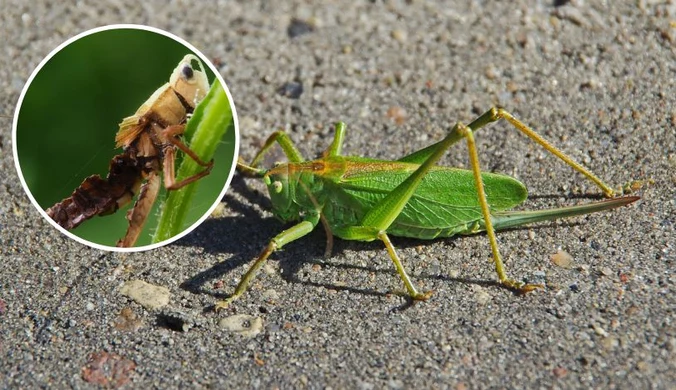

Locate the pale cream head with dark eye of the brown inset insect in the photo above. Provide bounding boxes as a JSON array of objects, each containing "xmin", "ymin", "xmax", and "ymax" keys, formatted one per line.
[{"xmin": 169, "ymin": 54, "xmax": 209, "ymax": 107}]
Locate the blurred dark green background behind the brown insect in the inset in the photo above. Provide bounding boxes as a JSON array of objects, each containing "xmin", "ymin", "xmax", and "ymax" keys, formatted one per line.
[{"xmin": 17, "ymin": 29, "xmax": 235, "ymax": 246}]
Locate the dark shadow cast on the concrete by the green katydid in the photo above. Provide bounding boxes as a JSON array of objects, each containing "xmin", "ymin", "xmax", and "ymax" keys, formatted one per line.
[{"xmin": 174, "ymin": 175, "xmax": 598, "ymax": 310}]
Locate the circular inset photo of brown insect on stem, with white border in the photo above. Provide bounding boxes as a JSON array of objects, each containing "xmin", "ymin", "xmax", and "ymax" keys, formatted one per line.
[{"xmin": 12, "ymin": 25, "xmax": 239, "ymax": 251}]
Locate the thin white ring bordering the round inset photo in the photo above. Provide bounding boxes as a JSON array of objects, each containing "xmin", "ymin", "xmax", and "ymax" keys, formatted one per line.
[{"xmin": 12, "ymin": 24, "xmax": 239, "ymax": 252}]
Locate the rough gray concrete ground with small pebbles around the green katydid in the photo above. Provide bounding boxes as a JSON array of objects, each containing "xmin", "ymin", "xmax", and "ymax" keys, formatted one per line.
[{"xmin": 0, "ymin": 0, "xmax": 676, "ymax": 389}]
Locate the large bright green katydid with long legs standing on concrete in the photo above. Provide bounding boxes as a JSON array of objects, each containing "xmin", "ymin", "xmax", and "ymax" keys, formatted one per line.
[{"xmin": 215, "ymin": 108, "xmax": 639, "ymax": 309}]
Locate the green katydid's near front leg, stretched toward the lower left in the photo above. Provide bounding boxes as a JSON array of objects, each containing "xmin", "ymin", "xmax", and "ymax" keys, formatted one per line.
[{"xmin": 215, "ymin": 215, "xmax": 319, "ymax": 310}]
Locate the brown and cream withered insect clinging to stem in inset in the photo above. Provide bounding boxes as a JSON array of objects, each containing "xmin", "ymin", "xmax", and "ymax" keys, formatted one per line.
[{"xmin": 47, "ymin": 54, "xmax": 213, "ymax": 247}]
